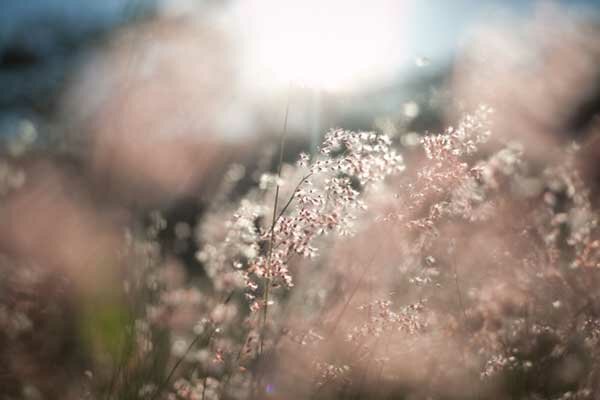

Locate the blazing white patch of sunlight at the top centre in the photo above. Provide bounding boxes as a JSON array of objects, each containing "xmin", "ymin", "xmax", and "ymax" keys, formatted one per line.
[{"xmin": 237, "ymin": 0, "xmax": 408, "ymax": 90}]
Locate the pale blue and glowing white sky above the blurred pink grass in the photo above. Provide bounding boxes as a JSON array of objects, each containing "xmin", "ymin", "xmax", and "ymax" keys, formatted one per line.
[{"xmin": 0, "ymin": 0, "xmax": 600, "ymax": 138}]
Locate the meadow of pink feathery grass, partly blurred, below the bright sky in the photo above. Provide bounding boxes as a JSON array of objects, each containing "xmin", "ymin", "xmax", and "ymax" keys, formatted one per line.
[{"xmin": 0, "ymin": 1, "xmax": 600, "ymax": 400}]
